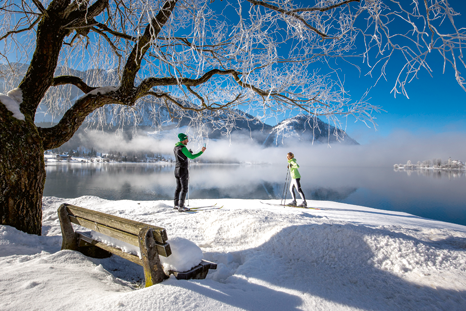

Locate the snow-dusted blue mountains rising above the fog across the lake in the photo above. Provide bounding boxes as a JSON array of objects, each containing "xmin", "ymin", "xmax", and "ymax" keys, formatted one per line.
[{"xmin": 75, "ymin": 102, "xmax": 359, "ymax": 147}]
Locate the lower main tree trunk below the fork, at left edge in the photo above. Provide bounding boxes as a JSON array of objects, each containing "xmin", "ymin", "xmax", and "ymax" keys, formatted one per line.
[{"xmin": 0, "ymin": 103, "xmax": 45, "ymax": 235}]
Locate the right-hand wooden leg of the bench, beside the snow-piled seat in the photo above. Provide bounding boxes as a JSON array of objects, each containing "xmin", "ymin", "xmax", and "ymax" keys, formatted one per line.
[{"xmin": 138, "ymin": 227, "xmax": 166, "ymax": 287}]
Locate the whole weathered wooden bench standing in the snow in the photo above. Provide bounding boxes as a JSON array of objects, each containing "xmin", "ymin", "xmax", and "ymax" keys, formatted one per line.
[{"xmin": 58, "ymin": 203, "xmax": 217, "ymax": 287}]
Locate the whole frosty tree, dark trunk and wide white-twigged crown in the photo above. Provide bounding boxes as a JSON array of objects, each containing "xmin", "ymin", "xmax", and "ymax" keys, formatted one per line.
[{"xmin": 0, "ymin": 0, "xmax": 466, "ymax": 234}]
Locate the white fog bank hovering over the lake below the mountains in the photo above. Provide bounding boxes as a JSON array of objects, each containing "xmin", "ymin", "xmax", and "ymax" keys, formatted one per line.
[{"xmin": 80, "ymin": 129, "xmax": 466, "ymax": 167}]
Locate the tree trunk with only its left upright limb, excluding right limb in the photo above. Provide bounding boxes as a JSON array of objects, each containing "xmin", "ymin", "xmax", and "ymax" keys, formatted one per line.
[{"xmin": 0, "ymin": 0, "xmax": 69, "ymax": 235}]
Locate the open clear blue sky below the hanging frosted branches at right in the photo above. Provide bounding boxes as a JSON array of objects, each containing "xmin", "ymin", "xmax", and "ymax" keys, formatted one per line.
[{"xmin": 345, "ymin": 0, "xmax": 466, "ymax": 144}]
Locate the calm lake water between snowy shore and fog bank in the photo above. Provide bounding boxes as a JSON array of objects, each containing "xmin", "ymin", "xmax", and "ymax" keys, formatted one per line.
[{"xmin": 44, "ymin": 164, "xmax": 466, "ymax": 225}]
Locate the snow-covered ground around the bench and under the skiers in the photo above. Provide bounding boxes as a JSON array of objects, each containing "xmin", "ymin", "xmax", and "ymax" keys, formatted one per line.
[{"xmin": 0, "ymin": 196, "xmax": 466, "ymax": 311}]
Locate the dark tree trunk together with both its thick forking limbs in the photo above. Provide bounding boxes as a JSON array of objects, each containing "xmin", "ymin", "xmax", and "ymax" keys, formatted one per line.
[{"xmin": 0, "ymin": 0, "xmax": 177, "ymax": 235}]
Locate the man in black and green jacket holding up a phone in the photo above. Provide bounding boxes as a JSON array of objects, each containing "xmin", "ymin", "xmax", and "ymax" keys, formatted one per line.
[{"xmin": 173, "ymin": 133, "xmax": 206, "ymax": 212}]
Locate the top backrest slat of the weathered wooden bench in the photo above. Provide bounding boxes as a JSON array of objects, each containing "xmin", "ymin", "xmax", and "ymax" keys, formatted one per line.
[{"xmin": 66, "ymin": 204, "xmax": 168, "ymax": 244}]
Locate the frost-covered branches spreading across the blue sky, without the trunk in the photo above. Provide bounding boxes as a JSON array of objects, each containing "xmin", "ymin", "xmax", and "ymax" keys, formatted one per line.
[{"xmin": 0, "ymin": 0, "xmax": 466, "ymax": 138}]
